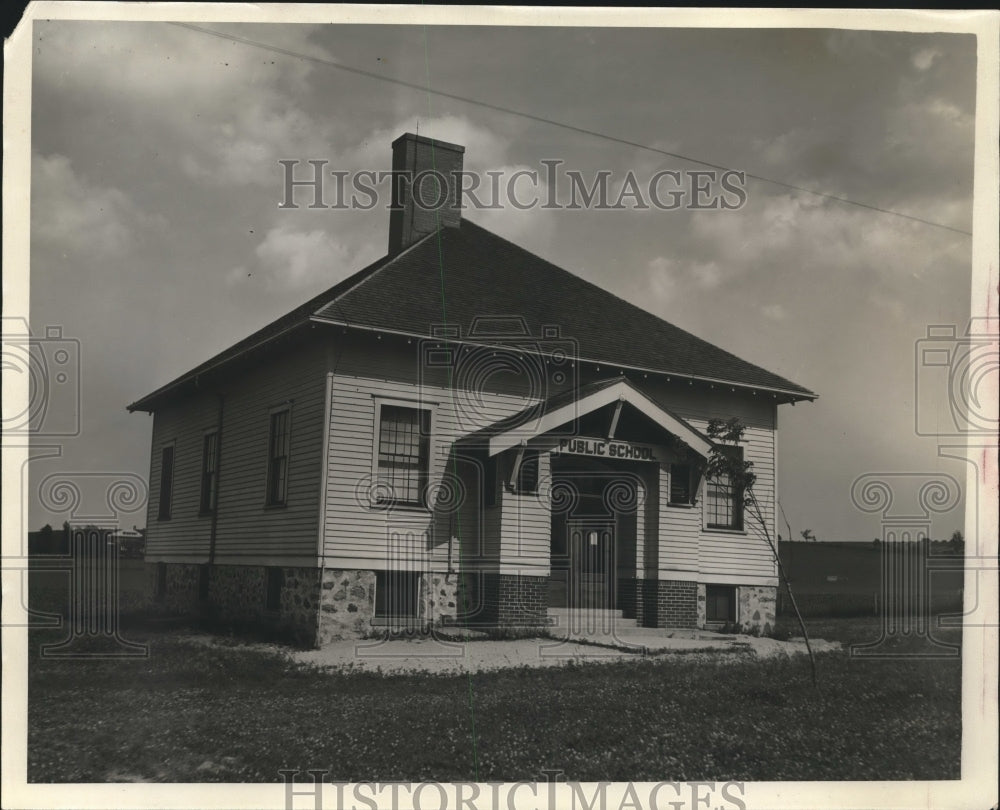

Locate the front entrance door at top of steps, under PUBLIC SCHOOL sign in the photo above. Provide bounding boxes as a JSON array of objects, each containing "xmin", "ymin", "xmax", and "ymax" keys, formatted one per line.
[{"xmin": 566, "ymin": 520, "xmax": 615, "ymax": 609}]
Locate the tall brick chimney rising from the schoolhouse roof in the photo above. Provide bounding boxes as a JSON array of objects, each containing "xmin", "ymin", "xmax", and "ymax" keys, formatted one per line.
[{"xmin": 389, "ymin": 132, "xmax": 465, "ymax": 255}]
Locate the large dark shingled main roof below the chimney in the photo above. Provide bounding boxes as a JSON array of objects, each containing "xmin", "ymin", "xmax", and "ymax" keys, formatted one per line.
[{"xmin": 129, "ymin": 219, "xmax": 816, "ymax": 410}]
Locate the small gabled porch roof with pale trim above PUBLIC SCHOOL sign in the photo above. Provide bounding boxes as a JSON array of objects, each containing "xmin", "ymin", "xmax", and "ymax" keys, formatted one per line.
[{"xmin": 466, "ymin": 377, "xmax": 713, "ymax": 458}]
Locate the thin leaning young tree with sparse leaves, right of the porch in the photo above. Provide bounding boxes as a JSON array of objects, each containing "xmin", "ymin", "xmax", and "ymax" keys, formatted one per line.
[{"xmin": 705, "ymin": 417, "xmax": 817, "ymax": 686}]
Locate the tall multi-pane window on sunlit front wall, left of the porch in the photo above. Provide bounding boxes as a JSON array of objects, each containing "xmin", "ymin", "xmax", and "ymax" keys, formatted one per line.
[{"xmin": 378, "ymin": 404, "xmax": 431, "ymax": 505}]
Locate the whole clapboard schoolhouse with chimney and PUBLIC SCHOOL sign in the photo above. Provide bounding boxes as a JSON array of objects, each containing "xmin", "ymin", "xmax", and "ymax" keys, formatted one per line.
[{"xmin": 129, "ymin": 134, "xmax": 816, "ymax": 645}]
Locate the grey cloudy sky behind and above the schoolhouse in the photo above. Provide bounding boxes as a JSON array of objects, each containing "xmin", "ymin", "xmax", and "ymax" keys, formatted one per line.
[{"xmin": 23, "ymin": 15, "xmax": 976, "ymax": 540}]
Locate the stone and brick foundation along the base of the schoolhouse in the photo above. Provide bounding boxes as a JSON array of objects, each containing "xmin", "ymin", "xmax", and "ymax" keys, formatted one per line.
[{"xmin": 136, "ymin": 563, "xmax": 777, "ymax": 646}]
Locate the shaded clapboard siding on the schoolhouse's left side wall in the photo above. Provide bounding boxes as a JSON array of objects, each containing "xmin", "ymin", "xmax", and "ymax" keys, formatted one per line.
[{"xmin": 147, "ymin": 347, "xmax": 326, "ymax": 565}]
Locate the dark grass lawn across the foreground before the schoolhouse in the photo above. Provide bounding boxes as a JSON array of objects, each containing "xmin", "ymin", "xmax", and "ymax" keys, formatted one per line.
[{"xmin": 28, "ymin": 619, "xmax": 961, "ymax": 782}]
